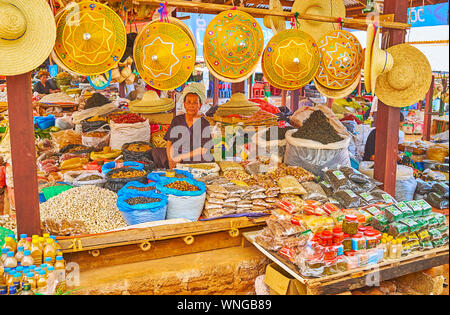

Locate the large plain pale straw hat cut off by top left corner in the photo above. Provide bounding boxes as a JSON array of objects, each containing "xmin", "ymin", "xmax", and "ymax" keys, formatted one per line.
[{"xmin": 0, "ymin": 0, "xmax": 56, "ymax": 76}]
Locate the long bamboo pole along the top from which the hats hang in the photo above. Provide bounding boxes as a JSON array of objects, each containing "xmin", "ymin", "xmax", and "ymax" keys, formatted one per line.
[{"xmin": 134, "ymin": 0, "xmax": 411, "ymax": 30}]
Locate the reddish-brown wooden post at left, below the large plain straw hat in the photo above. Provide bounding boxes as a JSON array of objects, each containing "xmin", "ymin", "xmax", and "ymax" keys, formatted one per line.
[{"xmin": 6, "ymin": 73, "xmax": 41, "ymax": 235}]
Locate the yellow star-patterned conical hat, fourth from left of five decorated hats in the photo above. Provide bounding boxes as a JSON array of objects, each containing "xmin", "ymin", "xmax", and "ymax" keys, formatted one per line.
[{"xmin": 262, "ymin": 29, "xmax": 320, "ymax": 90}]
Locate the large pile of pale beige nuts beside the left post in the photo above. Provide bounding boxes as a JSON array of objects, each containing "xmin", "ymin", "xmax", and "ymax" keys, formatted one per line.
[{"xmin": 40, "ymin": 185, "xmax": 127, "ymax": 233}]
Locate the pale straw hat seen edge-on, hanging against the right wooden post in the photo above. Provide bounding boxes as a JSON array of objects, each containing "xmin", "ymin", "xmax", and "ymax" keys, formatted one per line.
[{"xmin": 370, "ymin": 28, "xmax": 394, "ymax": 93}]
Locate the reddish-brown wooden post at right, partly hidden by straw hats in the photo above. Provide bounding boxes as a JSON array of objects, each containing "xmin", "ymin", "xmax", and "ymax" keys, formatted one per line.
[{"xmin": 374, "ymin": 0, "xmax": 408, "ymax": 196}]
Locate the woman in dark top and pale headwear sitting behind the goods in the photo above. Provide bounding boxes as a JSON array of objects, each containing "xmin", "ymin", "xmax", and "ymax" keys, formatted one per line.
[{"xmin": 152, "ymin": 83, "xmax": 214, "ymax": 168}]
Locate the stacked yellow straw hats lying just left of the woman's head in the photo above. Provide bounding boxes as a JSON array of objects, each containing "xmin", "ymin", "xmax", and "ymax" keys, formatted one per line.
[{"xmin": 129, "ymin": 91, "xmax": 175, "ymax": 114}]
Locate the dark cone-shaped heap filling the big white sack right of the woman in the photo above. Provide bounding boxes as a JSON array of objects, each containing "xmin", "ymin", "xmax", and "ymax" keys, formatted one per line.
[{"xmin": 292, "ymin": 110, "xmax": 344, "ymax": 144}]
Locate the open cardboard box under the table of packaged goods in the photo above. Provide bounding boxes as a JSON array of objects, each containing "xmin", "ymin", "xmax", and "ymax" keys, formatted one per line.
[{"xmin": 264, "ymin": 263, "xmax": 306, "ymax": 295}]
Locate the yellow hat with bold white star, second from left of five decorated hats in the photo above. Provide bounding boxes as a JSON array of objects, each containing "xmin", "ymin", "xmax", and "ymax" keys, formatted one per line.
[{"xmin": 134, "ymin": 19, "xmax": 196, "ymax": 90}]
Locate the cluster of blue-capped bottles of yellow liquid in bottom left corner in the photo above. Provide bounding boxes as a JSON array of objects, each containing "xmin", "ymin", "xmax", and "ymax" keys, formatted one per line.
[{"xmin": 0, "ymin": 234, "xmax": 66, "ymax": 295}]
